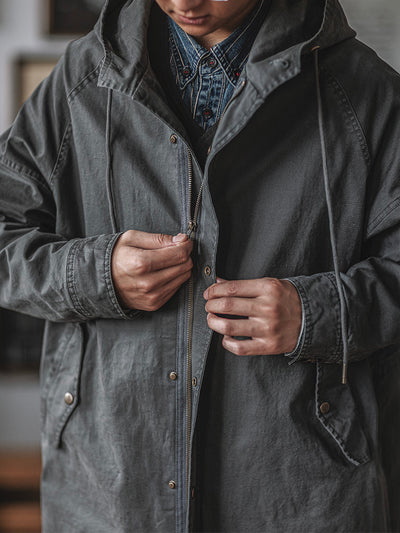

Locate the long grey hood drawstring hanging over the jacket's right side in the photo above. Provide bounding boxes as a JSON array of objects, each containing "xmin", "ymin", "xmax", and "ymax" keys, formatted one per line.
[{"xmin": 312, "ymin": 46, "xmax": 349, "ymax": 385}]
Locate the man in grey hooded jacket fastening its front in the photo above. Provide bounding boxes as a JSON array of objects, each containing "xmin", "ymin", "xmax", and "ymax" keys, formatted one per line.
[{"xmin": 0, "ymin": 0, "xmax": 400, "ymax": 533}]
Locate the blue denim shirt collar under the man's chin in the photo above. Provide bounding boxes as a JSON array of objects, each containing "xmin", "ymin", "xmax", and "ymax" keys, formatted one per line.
[{"xmin": 168, "ymin": 0, "xmax": 271, "ymax": 90}]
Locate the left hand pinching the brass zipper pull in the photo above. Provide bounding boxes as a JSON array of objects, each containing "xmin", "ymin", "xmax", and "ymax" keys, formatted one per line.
[{"xmin": 111, "ymin": 230, "xmax": 193, "ymax": 311}]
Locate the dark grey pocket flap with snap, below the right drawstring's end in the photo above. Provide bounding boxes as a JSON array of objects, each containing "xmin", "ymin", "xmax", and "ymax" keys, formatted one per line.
[{"xmin": 315, "ymin": 363, "xmax": 371, "ymax": 466}]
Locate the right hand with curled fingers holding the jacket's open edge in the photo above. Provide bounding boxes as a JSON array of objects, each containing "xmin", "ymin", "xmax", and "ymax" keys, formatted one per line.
[{"xmin": 204, "ymin": 278, "xmax": 302, "ymax": 355}]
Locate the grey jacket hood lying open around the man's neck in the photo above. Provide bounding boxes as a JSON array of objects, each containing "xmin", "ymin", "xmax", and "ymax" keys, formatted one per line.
[{"xmin": 95, "ymin": 0, "xmax": 355, "ymax": 96}]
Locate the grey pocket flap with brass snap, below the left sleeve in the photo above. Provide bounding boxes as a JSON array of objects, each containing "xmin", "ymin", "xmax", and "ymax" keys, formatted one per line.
[{"xmin": 42, "ymin": 323, "xmax": 83, "ymax": 448}]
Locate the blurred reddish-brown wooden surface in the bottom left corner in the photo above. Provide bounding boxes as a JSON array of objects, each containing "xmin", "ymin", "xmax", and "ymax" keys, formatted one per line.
[{"xmin": 0, "ymin": 450, "xmax": 41, "ymax": 533}]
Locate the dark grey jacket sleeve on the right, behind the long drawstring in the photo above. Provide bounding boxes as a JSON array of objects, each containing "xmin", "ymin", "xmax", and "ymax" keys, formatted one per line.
[{"xmin": 287, "ymin": 87, "xmax": 400, "ymax": 363}]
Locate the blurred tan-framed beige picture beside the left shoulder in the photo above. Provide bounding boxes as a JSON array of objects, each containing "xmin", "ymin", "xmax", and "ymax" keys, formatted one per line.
[{"xmin": 14, "ymin": 55, "xmax": 59, "ymax": 113}]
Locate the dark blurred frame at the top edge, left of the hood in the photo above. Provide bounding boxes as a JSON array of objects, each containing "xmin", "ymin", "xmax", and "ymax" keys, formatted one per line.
[{"xmin": 46, "ymin": 0, "xmax": 105, "ymax": 35}]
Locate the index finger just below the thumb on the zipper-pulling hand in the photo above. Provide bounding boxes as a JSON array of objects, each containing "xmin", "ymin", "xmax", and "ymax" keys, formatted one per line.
[{"xmin": 129, "ymin": 241, "xmax": 193, "ymax": 276}]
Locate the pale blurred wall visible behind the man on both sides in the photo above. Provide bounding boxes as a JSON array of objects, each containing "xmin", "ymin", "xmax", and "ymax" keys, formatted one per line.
[{"xmin": 0, "ymin": 0, "xmax": 400, "ymax": 447}]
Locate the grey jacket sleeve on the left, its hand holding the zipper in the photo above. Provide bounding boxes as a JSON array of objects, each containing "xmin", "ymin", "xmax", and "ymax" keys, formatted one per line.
[{"xmin": 0, "ymin": 52, "xmax": 134, "ymax": 321}]
